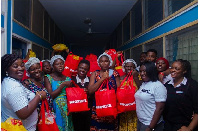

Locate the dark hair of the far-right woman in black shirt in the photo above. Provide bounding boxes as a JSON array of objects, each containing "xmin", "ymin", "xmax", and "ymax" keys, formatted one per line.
[{"xmin": 174, "ymin": 59, "xmax": 191, "ymax": 79}]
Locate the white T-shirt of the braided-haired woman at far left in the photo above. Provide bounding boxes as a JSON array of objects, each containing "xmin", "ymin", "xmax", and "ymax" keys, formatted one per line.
[{"xmin": 1, "ymin": 77, "xmax": 38, "ymax": 131}]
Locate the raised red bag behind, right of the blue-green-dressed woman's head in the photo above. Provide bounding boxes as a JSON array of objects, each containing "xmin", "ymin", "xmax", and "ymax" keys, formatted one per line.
[{"xmin": 62, "ymin": 52, "xmax": 83, "ymax": 77}]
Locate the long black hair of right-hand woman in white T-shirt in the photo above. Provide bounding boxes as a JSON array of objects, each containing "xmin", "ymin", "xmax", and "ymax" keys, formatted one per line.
[{"xmin": 142, "ymin": 61, "xmax": 158, "ymax": 82}]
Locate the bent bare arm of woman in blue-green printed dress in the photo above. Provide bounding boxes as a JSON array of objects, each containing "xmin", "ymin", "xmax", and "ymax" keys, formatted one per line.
[{"xmin": 44, "ymin": 76, "xmax": 71, "ymax": 99}]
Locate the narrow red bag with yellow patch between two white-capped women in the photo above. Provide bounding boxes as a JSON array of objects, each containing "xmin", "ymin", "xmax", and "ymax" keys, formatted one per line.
[{"xmin": 115, "ymin": 53, "xmax": 126, "ymax": 76}]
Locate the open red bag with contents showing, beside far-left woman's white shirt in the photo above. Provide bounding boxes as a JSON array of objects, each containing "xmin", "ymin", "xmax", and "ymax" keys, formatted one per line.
[{"xmin": 37, "ymin": 99, "xmax": 59, "ymax": 131}]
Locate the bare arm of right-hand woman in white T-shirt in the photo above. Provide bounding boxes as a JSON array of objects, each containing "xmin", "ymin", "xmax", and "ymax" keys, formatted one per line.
[{"xmin": 146, "ymin": 102, "xmax": 165, "ymax": 131}]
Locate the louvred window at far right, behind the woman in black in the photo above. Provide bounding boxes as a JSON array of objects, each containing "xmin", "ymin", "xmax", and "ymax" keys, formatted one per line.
[{"xmin": 166, "ymin": 25, "xmax": 198, "ymax": 81}]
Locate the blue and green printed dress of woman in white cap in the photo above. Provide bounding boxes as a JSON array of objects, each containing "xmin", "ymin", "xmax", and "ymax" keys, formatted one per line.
[{"xmin": 46, "ymin": 74, "xmax": 73, "ymax": 131}]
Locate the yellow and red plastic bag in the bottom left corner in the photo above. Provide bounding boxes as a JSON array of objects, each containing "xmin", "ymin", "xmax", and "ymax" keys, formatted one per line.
[{"xmin": 1, "ymin": 117, "xmax": 27, "ymax": 131}]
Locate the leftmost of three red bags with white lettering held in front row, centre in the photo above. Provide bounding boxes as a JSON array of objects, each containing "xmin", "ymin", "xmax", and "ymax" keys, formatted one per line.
[{"xmin": 65, "ymin": 81, "xmax": 90, "ymax": 114}]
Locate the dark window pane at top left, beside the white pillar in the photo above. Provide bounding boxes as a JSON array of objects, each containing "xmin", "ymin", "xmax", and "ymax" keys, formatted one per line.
[{"xmin": 13, "ymin": 0, "xmax": 31, "ymax": 28}]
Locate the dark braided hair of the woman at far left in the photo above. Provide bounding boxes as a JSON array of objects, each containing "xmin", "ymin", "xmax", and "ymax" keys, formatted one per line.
[{"xmin": 1, "ymin": 54, "xmax": 20, "ymax": 81}]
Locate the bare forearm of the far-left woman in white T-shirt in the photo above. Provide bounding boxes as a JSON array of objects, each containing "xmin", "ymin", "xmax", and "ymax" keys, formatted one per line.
[{"xmin": 15, "ymin": 91, "xmax": 46, "ymax": 120}]
